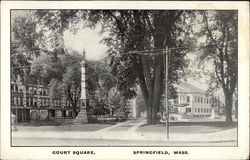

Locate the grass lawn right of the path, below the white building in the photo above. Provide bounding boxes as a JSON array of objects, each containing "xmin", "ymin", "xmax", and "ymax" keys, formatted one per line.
[{"xmin": 137, "ymin": 121, "xmax": 237, "ymax": 134}]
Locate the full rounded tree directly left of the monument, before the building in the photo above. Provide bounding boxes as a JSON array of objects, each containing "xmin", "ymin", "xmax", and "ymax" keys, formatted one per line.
[{"xmin": 31, "ymin": 52, "xmax": 83, "ymax": 117}]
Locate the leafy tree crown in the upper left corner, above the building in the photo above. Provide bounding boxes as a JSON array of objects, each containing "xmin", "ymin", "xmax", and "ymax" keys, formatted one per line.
[{"xmin": 10, "ymin": 11, "xmax": 40, "ymax": 80}]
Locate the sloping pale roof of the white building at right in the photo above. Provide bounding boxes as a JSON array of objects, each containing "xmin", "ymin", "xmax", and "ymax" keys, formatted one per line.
[{"xmin": 177, "ymin": 82, "xmax": 205, "ymax": 94}]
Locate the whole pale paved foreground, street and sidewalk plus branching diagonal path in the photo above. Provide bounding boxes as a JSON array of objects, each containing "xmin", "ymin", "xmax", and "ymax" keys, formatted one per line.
[{"xmin": 12, "ymin": 119, "xmax": 237, "ymax": 146}]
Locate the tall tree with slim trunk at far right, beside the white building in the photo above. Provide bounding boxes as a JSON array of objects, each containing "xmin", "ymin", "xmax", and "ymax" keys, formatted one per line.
[{"xmin": 200, "ymin": 11, "xmax": 238, "ymax": 124}]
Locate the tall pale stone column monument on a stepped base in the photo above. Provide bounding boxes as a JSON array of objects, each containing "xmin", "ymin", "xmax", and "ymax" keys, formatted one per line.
[{"xmin": 76, "ymin": 50, "xmax": 88, "ymax": 123}]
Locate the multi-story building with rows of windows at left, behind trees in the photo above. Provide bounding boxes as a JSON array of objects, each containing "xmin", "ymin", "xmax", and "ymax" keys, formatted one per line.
[{"xmin": 11, "ymin": 76, "xmax": 78, "ymax": 123}]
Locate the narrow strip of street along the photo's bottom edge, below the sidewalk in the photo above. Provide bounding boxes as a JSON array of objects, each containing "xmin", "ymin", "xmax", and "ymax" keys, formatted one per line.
[{"xmin": 12, "ymin": 138, "xmax": 236, "ymax": 147}]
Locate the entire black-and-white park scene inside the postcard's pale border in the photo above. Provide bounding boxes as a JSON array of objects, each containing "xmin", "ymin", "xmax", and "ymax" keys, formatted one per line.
[{"xmin": 10, "ymin": 9, "xmax": 238, "ymax": 146}]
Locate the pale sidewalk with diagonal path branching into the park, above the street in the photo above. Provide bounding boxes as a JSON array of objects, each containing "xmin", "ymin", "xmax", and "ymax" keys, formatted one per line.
[{"xmin": 12, "ymin": 120, "xmax": 237, "ymax": 143}]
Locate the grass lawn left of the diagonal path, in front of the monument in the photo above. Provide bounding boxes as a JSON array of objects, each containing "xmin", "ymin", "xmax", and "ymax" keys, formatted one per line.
[{"xmin": 17, "ymin": 123, "xmax": 113, "ymax": 132}]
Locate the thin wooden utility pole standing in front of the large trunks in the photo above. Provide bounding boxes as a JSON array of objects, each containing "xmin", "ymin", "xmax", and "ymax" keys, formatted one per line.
[{"xmin": 165, "ymin": 46, "xmax": 169, "ymax": 139}]
